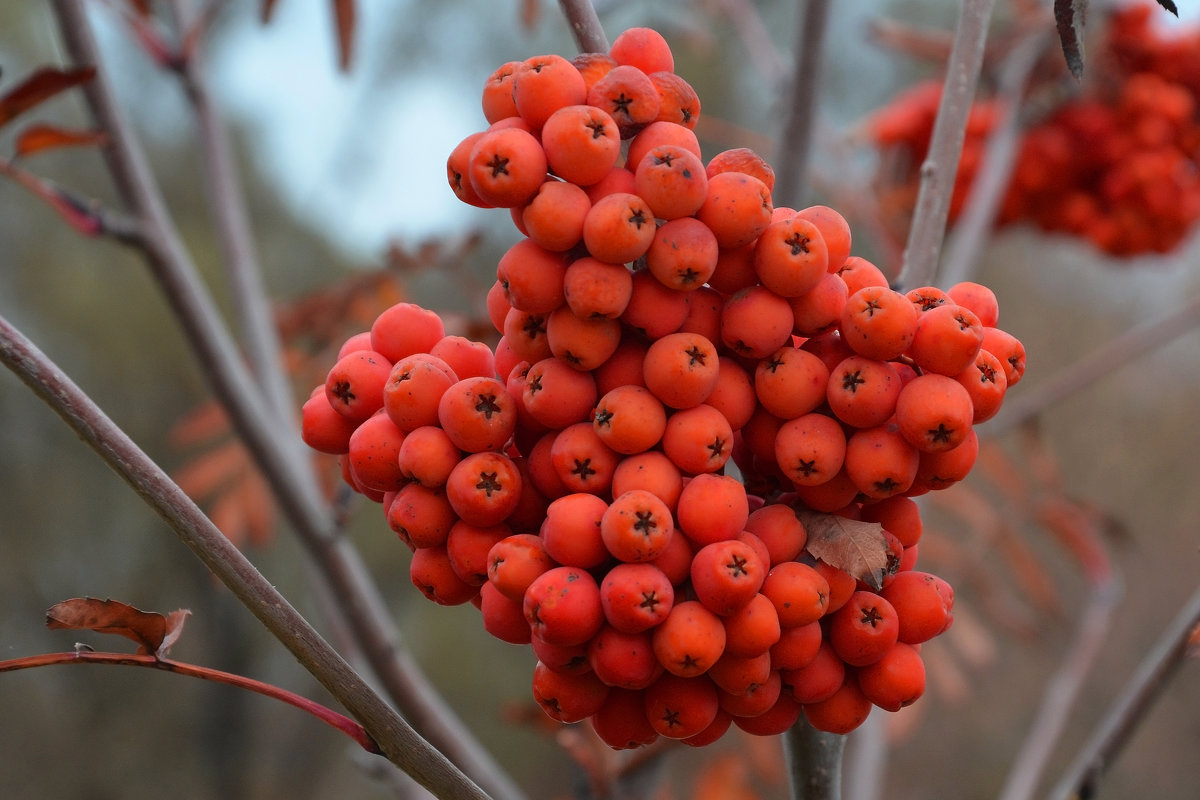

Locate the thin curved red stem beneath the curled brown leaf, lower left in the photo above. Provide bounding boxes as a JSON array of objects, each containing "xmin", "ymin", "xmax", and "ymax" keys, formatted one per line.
[{"xmin": 0, "ymin": 649, "xmax": 382, "ymax": 754}]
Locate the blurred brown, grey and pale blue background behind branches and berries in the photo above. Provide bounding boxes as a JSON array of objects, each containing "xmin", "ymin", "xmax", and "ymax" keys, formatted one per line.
[{"xmin": 0, "ymin": 0, "xmax": 1200, "ymax": 800}]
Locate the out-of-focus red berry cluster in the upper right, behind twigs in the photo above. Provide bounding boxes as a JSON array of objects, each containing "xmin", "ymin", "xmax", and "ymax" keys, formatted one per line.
[{"xmin": 869, "ymin": 4, "xmax": 1200, "ymax": 257}]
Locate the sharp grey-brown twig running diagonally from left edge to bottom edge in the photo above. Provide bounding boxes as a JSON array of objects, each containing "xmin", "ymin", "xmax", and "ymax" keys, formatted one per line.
[{"xmin": 0, "ymin": 317, "xmax": 487, "ymax": 799}]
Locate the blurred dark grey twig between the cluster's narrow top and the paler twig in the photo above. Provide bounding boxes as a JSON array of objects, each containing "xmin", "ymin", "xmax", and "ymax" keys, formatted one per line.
[{"xmin": 773, "ymin": 0, "xmax": 829, "ymax": 207}]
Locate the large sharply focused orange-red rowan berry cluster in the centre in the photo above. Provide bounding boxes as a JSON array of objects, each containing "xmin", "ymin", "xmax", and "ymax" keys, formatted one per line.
[{"xmin": 304, "ymin": 29, "xmax": 1025, "ymax": 748}]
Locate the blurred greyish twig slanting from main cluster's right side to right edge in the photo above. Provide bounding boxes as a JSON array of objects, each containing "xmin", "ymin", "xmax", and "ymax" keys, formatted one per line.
[{"xmin": 988, "ymin": 291, "xmax": 1200, "ymax": 435}]
